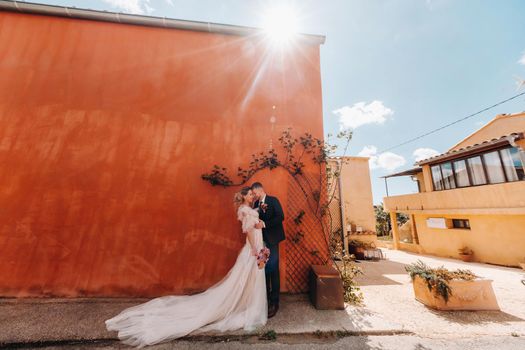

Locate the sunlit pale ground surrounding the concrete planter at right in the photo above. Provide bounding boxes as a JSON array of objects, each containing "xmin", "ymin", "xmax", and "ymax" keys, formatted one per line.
[{"xmin": 359, "ymin": 249, "xmax": 525, "ymax": 340}]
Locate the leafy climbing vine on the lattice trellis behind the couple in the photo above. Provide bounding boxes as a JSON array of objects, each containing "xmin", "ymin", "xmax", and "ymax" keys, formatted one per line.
[{"xmin": 202, "ymin": 128, "xmax": 362, "ymax": 303}]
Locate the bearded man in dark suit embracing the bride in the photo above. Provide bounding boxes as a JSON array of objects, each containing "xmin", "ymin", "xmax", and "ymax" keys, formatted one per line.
[{"xmin": 252, "ymin": 182, "xmax": 285, "ymax": 318}]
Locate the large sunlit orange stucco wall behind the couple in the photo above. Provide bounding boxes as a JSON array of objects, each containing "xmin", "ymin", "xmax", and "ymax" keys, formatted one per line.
[{"xmin": 0, "ymin": 12, "xmax": 323, "ymax": 296}]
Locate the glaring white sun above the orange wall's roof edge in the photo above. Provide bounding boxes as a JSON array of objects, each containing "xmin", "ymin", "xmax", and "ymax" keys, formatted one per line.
[{"xmin": 263, "ymin": 6, "xmax": 297, "ymax": 46}]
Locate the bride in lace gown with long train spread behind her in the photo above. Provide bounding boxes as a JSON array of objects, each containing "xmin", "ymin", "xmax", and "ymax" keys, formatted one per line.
[{"xmin": 105, "ymin": 187, "xmax": 267, "ymax": 347}]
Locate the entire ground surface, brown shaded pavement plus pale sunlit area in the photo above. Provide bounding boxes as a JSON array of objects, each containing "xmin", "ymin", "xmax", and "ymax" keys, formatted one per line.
[{"xmin": 0, "ymin": 249, "xmax": 525, "ymax": 350}]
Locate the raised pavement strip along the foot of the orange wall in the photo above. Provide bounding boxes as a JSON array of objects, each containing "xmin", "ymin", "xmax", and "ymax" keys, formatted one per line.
[{"xmin": 0, "ymin": 295, "xmax": 406, "ymax": 346}]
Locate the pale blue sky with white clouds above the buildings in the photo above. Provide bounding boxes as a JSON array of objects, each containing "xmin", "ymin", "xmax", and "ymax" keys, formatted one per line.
[{"xmin": 33, "ymin": 0, "xmax": 525, "ymax": 203}]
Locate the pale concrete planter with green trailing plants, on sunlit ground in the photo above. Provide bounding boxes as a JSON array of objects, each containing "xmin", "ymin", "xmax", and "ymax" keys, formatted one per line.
[{"xmin": 405, "ymin": 261, "xmax": 499, "ymax": 310}]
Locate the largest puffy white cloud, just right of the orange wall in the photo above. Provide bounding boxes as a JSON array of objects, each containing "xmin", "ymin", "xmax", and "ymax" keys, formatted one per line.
[{"xmin": 333, "ymin": 101, "xmax": 394, "ymax": 129}]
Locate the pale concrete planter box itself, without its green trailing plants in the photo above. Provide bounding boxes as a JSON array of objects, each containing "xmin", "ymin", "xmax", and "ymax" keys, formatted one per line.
[{"xmin": 413, "ymin": 276, "xmax": 500, "ymax": 310}]
